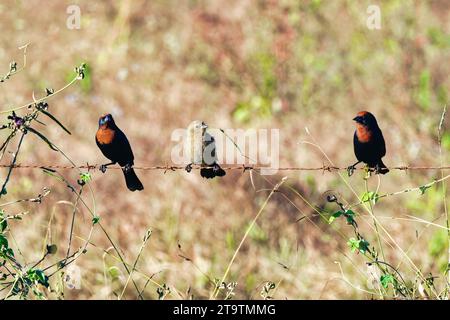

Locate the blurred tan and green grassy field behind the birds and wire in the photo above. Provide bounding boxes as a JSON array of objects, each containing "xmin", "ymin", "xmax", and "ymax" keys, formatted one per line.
[{"xmin": 0, "ymin": 0, "xmax": 450, "ymax": 299}]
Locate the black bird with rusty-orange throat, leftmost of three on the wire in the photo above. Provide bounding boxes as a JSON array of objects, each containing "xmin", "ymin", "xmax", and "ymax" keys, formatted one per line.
[{"xmin": 95, "ymin": 114, "xmax": 144, "ymax": 191}]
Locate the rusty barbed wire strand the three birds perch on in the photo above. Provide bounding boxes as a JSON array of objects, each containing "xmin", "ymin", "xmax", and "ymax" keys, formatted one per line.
[{"xmin": 0, "ymin": 163, "xmax": 450, "ymax": 172}]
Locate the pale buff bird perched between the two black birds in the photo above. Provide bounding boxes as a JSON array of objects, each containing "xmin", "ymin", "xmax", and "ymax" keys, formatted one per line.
[{"xmin": 185, "ymin": 120, "xmax": 225, "ymax": 179}]
